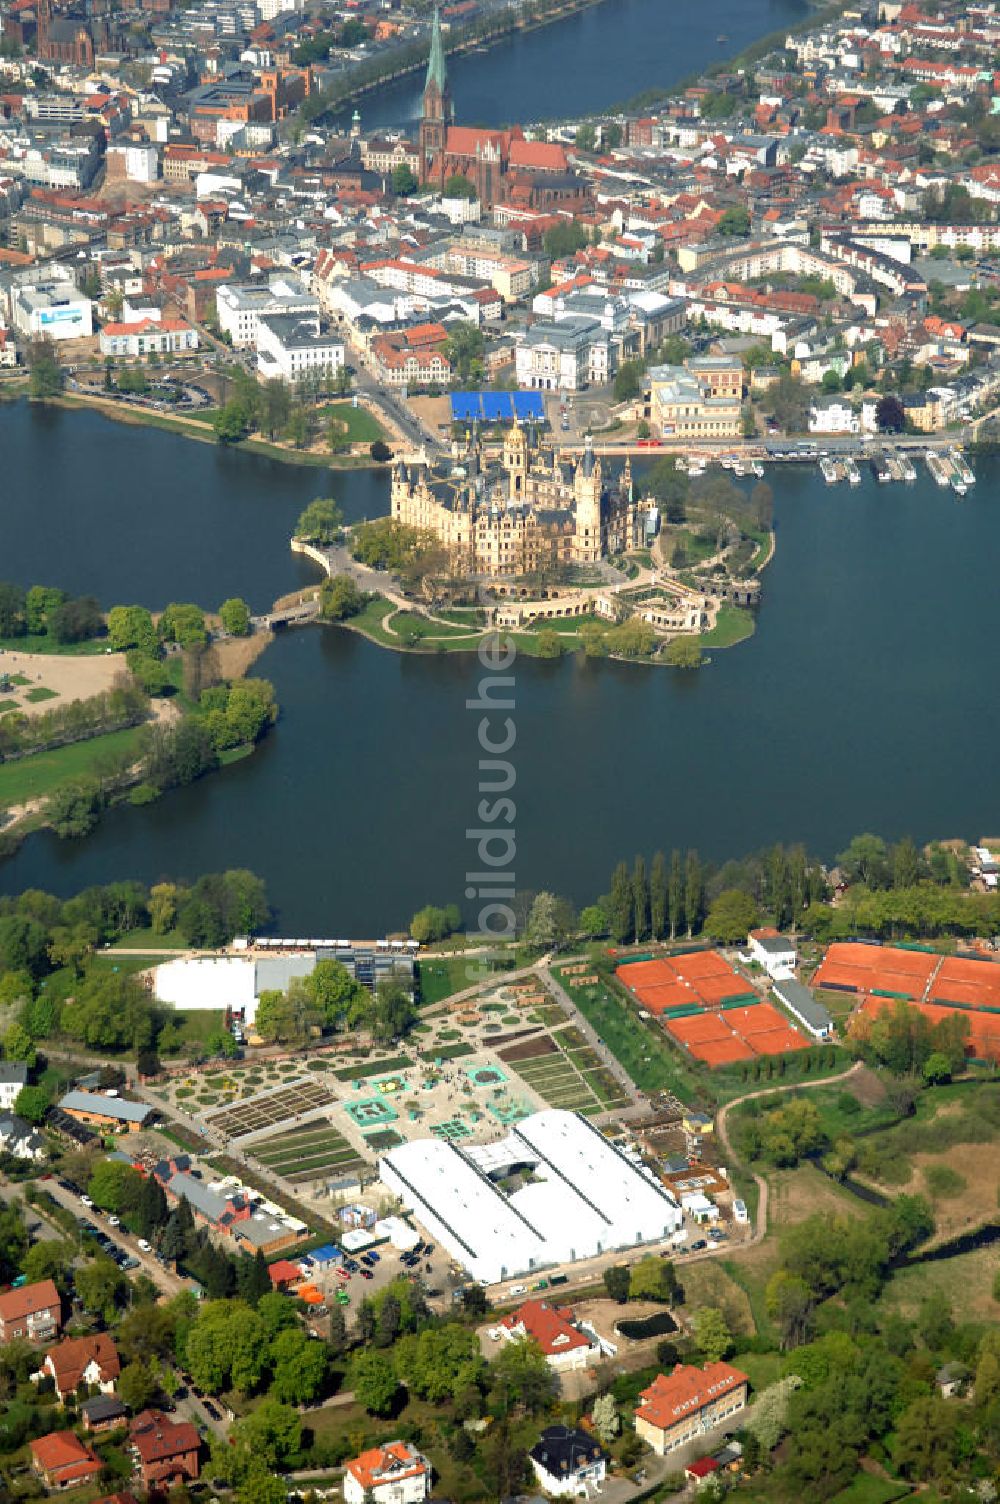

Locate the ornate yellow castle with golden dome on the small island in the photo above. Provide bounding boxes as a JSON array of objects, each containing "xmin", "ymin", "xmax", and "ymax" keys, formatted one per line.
[{"xmin": 391, "ymin": 421, "xmax": 647, "ymax": 579}]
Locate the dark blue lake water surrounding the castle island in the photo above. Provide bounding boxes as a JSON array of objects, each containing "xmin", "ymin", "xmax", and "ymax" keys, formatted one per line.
[{"xmin": 0, "ymin": 403, "xmax": 1000, "ymax": 935}]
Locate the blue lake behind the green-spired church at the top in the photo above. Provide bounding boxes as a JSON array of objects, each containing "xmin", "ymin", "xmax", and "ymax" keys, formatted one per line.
[{"xmin": 343, "ymin": 0, "xmax": 809, "ymax": 129}]
